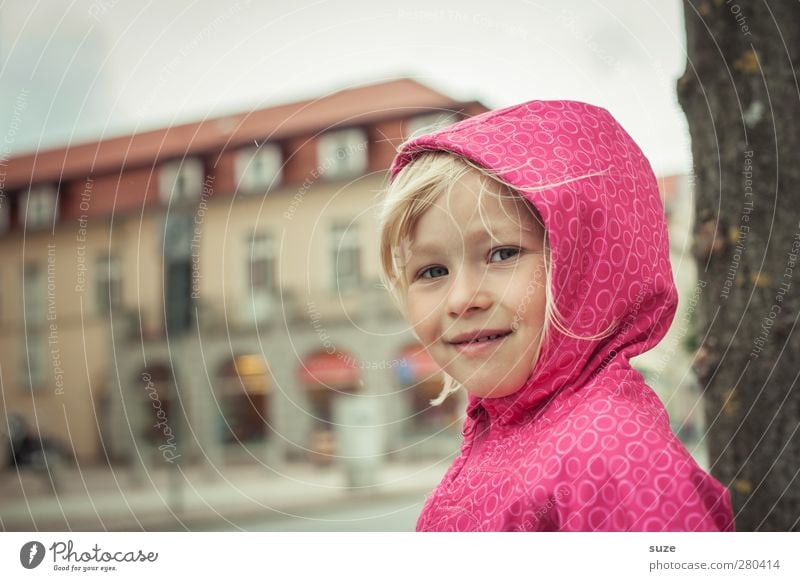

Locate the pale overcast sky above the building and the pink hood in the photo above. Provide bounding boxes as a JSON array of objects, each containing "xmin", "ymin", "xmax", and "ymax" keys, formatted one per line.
[{"xmin": 0, "ymin": 0, "xmax": 691, "ymax": 175}]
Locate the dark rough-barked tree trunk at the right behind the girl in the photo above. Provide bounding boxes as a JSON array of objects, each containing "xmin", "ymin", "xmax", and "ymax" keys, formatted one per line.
[{"xmin": 677, "ymin": 0, "xmax": 800, "ymax": 531}]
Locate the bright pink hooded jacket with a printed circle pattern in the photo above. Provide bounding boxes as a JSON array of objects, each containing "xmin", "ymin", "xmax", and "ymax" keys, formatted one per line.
[{"xmin": 390, "ymin": 101, "xmax": 734, "ymax": 531}]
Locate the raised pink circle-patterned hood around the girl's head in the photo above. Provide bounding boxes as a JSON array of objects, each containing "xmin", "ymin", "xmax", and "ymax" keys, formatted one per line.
[{"xmin": 390, "ymin": 101, "xmax": 677, "ymax": 423}]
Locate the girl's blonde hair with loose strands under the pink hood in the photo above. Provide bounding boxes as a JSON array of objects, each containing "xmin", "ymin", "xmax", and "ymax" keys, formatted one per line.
[{"xmin": 378, "ymin": 151, "xmax": 616, "ymax": 405}]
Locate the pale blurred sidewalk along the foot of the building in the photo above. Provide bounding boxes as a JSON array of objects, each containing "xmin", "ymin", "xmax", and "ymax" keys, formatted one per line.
[{"xmin": 0, "ymin": 460, "xmax": 449, "ymax": 531}]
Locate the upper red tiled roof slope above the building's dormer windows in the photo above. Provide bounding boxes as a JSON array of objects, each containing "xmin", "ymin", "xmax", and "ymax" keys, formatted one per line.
[{"xmin": 5, "ymin": 79, "xmax": 472, "ymax": 189}]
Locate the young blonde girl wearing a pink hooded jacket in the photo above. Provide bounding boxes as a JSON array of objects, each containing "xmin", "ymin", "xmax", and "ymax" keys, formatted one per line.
[{"xmin": 380, "ymin": 101, "xmax": 733, "ymax": 531}]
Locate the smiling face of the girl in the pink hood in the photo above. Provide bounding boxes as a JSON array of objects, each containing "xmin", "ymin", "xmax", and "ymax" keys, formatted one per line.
[{"xmin": 405, "ymin": 172, "xmax": 545, "ymax": 397}]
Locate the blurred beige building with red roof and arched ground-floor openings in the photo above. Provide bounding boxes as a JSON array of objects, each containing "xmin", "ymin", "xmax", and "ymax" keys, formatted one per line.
[{"xmin": 0, "ymin": 79, "xmax": 487, "ymax": 464}]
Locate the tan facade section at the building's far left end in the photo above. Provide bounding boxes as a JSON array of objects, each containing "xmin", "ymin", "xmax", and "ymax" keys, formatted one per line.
[{"xmin": 0, "ymin": 213, "xmax": 112, "ymax": 456}]
